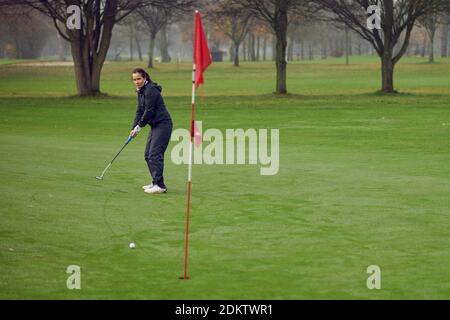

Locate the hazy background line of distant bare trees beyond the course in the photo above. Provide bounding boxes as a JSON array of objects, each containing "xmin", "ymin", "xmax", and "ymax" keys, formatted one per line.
[{"xmin": 0, "ymin": 0, "xmax": 450, "ymax": 95}]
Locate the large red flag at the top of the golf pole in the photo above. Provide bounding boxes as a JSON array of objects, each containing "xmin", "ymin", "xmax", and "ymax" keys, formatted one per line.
[{"xmin": 194, "ymin": 11, "xmax": 211, "ymax": 89}]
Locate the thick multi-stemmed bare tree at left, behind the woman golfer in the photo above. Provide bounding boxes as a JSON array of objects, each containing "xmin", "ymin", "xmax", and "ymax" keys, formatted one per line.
[{"xmin": 0, "ymin": 0, "xmax": 153, "ymax": 96}]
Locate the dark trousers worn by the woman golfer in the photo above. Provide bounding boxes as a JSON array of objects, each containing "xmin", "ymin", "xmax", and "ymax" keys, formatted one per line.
[{"xmin": 144, "ymin": 120, "xmax": 172, "ymax": 188}]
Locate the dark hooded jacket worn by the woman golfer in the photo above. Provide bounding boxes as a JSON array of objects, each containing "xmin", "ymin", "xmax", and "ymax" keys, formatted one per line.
[{"xmin": 132, "ymin": 82, "xmax": 171, "ymax": 129}]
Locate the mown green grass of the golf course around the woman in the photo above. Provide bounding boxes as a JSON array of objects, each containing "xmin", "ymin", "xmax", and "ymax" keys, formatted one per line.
[{"xmin": 0, "ymin": 58, "xmax": 450, "ymax": 299}]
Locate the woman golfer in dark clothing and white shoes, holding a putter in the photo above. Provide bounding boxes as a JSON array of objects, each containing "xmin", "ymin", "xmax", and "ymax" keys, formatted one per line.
[{"xmin": 130, "ymin": 68, "xmax": 172, "ymax": 194}]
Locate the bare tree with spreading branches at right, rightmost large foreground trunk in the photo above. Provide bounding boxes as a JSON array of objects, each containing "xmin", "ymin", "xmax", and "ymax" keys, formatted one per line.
[{"xmin": 315, "ymin": 0, "xmax": 447, "ymax": 93}]
